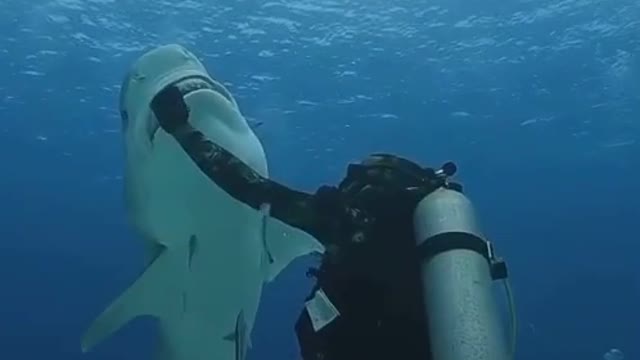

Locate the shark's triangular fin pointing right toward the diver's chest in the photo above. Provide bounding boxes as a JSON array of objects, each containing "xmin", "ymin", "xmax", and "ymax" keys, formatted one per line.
[{"xmin": 264, "ymin": 216, "xmax": 324, "ymax": 281}]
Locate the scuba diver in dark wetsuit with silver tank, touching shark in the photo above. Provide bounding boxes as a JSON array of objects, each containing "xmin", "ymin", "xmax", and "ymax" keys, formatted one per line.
[{"xmin": 151, "ymin": 85, "xmax": 515, "ymax": 360}]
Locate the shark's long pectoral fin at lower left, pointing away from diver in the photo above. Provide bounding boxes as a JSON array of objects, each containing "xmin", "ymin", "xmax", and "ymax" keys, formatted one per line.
[{"xmin": 82, "ymin": 248, "xmax": 180, "ymax": 352}]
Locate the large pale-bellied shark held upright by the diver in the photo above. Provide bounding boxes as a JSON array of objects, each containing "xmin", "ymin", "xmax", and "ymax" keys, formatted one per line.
[{"xmin": 82, "ymin": 44, "xmax": 324, "ymax": 360}]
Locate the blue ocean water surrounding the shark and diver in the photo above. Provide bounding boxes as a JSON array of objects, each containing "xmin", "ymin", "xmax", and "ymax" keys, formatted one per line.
[{"xmin": 0, "ymin": 0, "xmax": 640, "ymax": 360}]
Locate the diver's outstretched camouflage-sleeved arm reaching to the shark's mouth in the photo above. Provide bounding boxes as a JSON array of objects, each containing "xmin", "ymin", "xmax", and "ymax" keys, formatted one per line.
[{"xmin": 151, "ymin": 86, "xmax": 339, "ymax": 242}]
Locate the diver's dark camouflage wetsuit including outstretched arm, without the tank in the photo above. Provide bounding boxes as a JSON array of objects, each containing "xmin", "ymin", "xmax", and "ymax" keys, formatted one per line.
[{"xmin": 152, "ymin": 86, "xmax": 459, "ymax": 360}]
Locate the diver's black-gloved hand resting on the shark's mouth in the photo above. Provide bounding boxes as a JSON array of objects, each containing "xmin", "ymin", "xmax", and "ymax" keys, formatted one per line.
[{"xmin": 151, "ymin": 85, "xmax": 189, "ymax": 134}]
